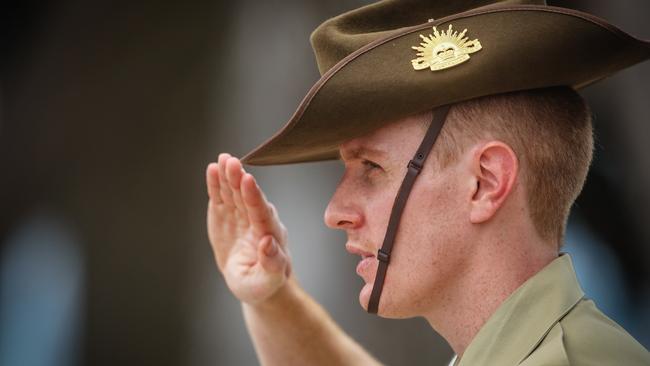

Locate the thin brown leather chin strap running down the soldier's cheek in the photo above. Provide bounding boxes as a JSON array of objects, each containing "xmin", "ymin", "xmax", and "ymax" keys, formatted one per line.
[{"xmin": 368, "ymin": 105, "xmax": 449, "ymax": 314}]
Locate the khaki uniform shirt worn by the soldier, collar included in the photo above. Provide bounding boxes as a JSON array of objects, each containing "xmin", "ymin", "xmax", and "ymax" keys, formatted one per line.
[{"xmin": 451, "ymin": 254, "xmax": 650, "ymax": 366}]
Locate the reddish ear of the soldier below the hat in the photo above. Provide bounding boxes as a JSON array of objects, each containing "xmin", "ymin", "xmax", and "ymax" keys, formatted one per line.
[{"xmin": 470, "ymin": 141, "xmax": 519, "ymax": 224}]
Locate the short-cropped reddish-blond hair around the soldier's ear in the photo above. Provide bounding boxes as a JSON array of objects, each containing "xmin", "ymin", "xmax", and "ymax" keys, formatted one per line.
[{"xmin": 433, "ymin": 87, "xmax": 594, "ymax": 247}]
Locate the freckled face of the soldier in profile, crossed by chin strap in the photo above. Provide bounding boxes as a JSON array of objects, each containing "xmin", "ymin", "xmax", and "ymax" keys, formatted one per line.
[{"xmin": 325, "ymin": 115, "xmax": 475, "ymax": 318}]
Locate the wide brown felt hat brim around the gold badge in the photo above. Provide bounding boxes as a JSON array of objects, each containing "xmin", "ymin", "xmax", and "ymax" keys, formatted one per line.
[{"xmin": 242, "ymin": 5, "xmax": 650, "ymax": 165}]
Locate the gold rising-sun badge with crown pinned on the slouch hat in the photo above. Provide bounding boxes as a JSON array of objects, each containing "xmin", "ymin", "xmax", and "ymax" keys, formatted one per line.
[{"xmin": 411, "ymin": 24, "xmax": 482, "ymax": 71}]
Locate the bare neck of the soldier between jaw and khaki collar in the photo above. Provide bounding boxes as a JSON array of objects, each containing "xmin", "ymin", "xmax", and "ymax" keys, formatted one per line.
[{"xmin": 424, "ymin": 234, "xmax": 557, "ymax": 358}]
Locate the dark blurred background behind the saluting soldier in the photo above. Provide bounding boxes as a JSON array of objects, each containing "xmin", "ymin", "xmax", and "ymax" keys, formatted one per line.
[{"xmin": 0, "ymin": 0, "xmax": 650, "ymax": 366}]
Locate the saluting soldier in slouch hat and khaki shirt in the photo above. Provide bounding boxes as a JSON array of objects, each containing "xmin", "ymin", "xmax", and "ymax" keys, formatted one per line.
[{"xmin": 206, "ymin": 0, "xmax": 650, "ymax": 366}]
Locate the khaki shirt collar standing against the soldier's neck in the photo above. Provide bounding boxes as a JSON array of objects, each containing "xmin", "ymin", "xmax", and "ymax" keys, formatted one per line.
[{"xmin": 452, "ymin": 253, "xmax": 584, "ymax": 366}]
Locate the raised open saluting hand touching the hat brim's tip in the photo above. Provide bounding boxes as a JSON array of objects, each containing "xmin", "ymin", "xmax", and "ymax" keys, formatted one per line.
[{"xmin": 206, "ymin": 154, "xmax": 291, "ymax": 304}]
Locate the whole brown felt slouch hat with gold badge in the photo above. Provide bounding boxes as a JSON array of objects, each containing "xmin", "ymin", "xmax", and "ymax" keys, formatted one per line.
[{"xmin": 242, "ymin": 0, "xmax": 650, "ymax": 165}]
